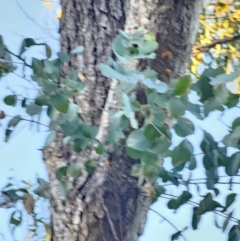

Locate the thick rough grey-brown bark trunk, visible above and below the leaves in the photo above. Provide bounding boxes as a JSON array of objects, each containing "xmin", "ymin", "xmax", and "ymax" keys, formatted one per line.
[{"xmin": 44, "ymin": 0, "xmax": 201, "ymax": 241}]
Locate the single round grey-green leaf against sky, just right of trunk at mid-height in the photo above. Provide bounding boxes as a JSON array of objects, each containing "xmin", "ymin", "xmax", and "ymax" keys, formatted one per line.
[{"xmin": 174, "ymin": 117, "xmax": 195, "ymax": 137}]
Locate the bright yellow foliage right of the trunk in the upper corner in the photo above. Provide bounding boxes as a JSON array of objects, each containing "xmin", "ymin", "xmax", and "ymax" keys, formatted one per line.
[{"xmin": 190, "ymin": 0, "xmax": 240, "ymax": 93}]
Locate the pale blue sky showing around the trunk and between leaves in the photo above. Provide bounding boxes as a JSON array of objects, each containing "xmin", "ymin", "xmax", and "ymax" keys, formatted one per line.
[{"xmin": 0, "ymin": 0, "xmax": 240, "ymax": 241}]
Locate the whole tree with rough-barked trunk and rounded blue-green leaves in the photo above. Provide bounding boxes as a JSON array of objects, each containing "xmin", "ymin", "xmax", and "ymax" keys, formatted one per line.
[{"xmin": 2, "ymin": 1, "xmax": 239, "ymax": 240}]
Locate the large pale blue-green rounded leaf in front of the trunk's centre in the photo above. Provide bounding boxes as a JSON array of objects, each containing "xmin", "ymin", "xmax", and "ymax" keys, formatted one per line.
[{"xmin": 126, "ymin": 130, "xmax": 152, "ymax": 151}]
